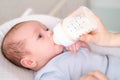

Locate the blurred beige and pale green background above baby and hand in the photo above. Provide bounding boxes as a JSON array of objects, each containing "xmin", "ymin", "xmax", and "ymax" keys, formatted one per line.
[{"xmin": 0, "ymin": 0, "xmax": 120, "ymax": 32}]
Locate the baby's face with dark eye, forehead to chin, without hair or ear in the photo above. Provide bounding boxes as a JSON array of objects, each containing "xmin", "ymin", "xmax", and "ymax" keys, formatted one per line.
[{"xmin": 9, "ymin": 21, "xmax": 63, "ymax": 69}]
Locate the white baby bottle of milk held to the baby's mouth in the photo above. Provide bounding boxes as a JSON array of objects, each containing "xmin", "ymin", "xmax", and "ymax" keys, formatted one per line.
[{"xmin": 53, "ymin": 6, "xmax": 96, "ymax": 46}]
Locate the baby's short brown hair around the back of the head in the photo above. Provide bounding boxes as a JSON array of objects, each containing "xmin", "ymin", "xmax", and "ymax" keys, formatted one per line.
[{"xmin": 1, "ymin": 22, "xmax": 27, "ymax": 68}]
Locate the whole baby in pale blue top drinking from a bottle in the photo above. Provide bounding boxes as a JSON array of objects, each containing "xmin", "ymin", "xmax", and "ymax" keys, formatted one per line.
[{"xmin": 1, "ymin": 7, "xmax": 120, "ymax": 80}]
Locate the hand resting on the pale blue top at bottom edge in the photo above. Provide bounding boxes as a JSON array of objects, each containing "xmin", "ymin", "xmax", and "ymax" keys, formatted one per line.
[{"xmin": 80, "ymin": 71, "xmax": 109, "ymax": 80}]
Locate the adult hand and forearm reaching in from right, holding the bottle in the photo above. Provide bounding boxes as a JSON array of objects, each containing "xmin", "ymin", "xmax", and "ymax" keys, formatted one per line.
[{"xmin": 69, "ymin": 6, "xmax": 120, "ymax": 47}]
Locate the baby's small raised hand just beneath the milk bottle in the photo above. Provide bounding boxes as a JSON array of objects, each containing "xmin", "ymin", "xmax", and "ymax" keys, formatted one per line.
[{"xmin": 65, "ymin": 40, "xmax": 90, "ymax": 53}]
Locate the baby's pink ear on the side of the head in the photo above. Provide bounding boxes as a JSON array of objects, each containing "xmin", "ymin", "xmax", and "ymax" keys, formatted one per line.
[{"xmin": 20, "ymin": 57, "xmax": 36, "ymax": 69}]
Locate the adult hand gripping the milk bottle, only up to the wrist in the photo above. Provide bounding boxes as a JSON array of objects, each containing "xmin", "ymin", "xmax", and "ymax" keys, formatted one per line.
[{"xmin": 74, "ymin": 7, "xmax": 111, "ymax": 46}]
